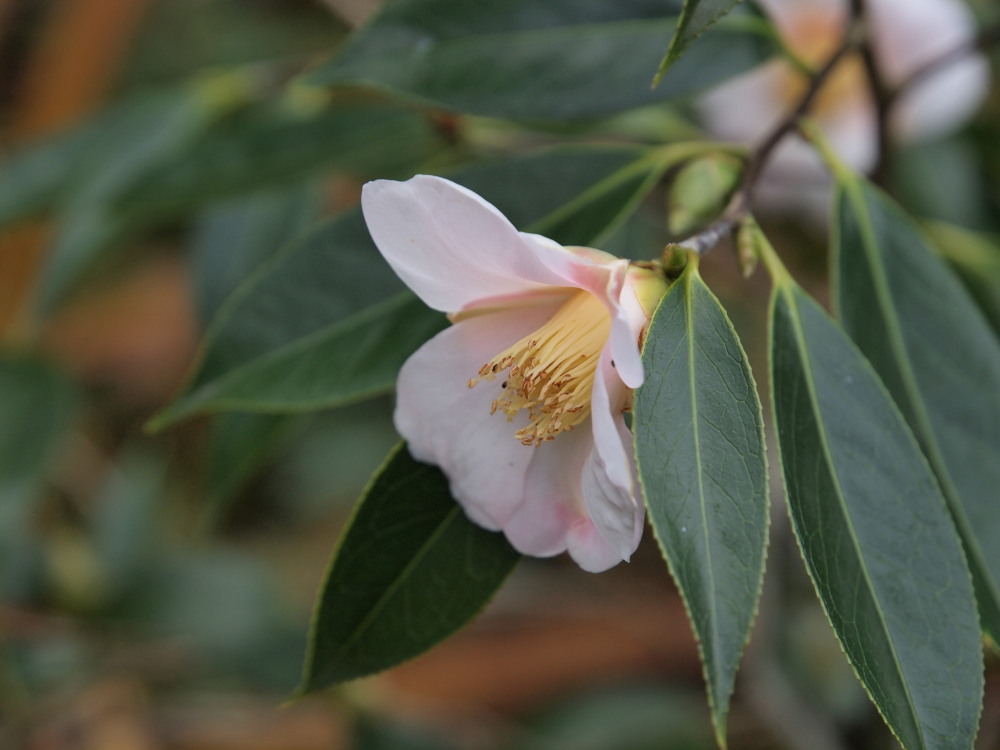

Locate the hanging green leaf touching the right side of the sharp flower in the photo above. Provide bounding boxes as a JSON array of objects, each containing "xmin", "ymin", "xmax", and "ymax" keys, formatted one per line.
[{"xmin": 633, "ymin": 260, "xmax": 768, "ymax": 746}]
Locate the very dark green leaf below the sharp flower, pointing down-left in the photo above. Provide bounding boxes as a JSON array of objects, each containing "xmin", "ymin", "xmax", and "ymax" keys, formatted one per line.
[{"xmin": 300, "ymin": 446, "xmax": 520, "ymax": 692}]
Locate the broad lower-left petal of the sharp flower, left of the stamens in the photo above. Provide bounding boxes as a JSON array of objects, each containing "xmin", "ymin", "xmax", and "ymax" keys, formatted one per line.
[{"xmin": 395, "ymin": 306, "xmax": 554, "ymax": 530}]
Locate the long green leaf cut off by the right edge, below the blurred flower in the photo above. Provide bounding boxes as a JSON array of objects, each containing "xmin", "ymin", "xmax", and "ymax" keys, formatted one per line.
[{"xmin": 833, "ymin": 176, "xmax": 1000, "ymax": 643}]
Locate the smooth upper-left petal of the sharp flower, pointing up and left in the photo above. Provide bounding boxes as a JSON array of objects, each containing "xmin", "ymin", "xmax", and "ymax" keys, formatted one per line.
[{"xmin": 361, "ymin": 175, "xmax": 566, "ymax": 312}]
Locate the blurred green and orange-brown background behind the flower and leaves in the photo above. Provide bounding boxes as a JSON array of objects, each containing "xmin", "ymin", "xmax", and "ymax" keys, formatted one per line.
[{"xmin": 0, "ymin": 0, "xmax": 1000, "ymax": 750}]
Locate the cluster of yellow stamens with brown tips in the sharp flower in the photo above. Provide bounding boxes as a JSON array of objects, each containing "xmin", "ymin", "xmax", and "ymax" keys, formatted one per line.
[{"xmin": 469, "ymin": 290, "xmax": 611, "ymax": 446}]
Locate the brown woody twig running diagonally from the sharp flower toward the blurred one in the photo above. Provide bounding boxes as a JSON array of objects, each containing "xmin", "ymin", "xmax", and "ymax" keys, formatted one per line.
[{"xmin": 679, "ymin": 25, "xmax": 858, "ymax": 255}]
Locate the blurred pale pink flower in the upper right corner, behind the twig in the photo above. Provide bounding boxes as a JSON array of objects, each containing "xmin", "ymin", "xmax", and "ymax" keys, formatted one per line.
[{"xmin": 699, "ymin": 0, "xmax": 988, "ymax": 175}]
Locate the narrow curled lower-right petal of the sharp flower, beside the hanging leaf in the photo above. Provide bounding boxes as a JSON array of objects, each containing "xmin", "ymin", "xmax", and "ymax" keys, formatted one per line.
[{"xmin": 582, "ymin": 352, "xmax": 643, "ymax": 560}]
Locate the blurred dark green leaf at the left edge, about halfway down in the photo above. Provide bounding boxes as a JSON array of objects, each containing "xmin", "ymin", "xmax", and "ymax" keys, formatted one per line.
[{"xmin": 0, "ymin": 354, "xmax": 78, "ymax": 598}]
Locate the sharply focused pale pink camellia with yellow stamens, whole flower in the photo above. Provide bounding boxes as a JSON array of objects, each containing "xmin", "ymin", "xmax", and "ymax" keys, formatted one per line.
[{"xmin": 361, "ymin": 175, "xmax": 666, "ymax": 571}]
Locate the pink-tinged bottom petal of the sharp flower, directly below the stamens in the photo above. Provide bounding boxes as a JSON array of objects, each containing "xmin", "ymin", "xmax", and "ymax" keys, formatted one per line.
[{"xmin": 504, "ymin": 424, "xmax": 592, "ymax": 562}]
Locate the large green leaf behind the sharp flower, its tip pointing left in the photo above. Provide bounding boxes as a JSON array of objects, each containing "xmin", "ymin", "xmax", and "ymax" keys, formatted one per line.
[{"xmin": 154, "ymin": 148, "xmax": 686, "ymax": 427}]
